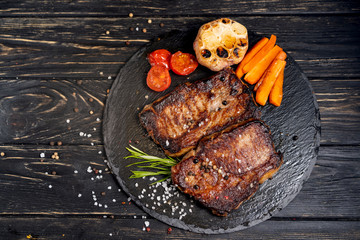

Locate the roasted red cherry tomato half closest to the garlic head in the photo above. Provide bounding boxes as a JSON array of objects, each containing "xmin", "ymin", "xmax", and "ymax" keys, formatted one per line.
[{"xmin": 170, "ymin": 51, "xmax": 199, "ymax": 76}]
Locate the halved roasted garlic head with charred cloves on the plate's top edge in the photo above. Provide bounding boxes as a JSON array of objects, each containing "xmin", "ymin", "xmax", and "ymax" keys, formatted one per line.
[{"xmin": 194, "ymin": 18, "xmax": 248, "ymax": 71}]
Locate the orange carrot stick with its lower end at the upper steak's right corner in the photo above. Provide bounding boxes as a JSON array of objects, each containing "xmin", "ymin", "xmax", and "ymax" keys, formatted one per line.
[{"xmin": 255, "ymin": 60, "xmax": 286, "ymax": 106}]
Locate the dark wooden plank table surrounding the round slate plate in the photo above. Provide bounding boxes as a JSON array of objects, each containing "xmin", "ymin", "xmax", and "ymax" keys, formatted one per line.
[{"xmin": 0, "ymin": 0, "xmax": 360, "ymax": 239}]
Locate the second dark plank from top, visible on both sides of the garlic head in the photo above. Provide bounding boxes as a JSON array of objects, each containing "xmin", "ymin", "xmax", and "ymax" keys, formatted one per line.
[{"xmin": 0, "ymin": 15, "xmax": 360, "ymax": 79}]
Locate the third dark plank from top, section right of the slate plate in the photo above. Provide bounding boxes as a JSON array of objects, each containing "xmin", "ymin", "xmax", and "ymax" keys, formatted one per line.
[{"xmin": 311, "ymin": 79, "xmax": 360, "ymax": 145}]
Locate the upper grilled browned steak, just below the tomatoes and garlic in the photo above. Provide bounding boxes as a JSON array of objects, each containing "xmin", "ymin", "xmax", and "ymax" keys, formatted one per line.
[{"xmin": 139, "ymin": 68, "xmax": 260, "ymax": 157}]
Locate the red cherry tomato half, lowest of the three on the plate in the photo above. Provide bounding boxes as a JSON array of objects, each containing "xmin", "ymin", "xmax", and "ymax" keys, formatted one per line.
[{"xmin": 146, "ymin": 65, "xmax": 171, "ymax": 92}]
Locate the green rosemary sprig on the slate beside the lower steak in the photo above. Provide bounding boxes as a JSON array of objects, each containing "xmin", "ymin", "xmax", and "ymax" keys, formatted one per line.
[{"xmin": 124, "ymin": 145, "xmax": 178, "ymax": 184}]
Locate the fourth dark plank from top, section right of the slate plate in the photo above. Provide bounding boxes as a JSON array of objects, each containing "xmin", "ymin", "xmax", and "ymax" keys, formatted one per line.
[{"xmin": 276, "ymin": 146, "xmax": 360, "ymax": 217}]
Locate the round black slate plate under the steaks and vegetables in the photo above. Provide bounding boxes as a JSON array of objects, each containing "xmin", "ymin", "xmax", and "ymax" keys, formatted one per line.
[{"xmin": 103, "ymin": 31, "xmax": 320, "ymax": 234}]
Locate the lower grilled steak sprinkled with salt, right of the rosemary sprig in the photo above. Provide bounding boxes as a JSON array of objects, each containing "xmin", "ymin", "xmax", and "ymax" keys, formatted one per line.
[{"xmin": 171, "ymin": 120, "xmax": 282, "ymax": 216}]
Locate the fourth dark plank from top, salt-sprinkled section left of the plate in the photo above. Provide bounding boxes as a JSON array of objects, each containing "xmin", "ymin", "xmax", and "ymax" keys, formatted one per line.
[{"xmin": 0, "ymin": 145, "xmax": 144, "ymax": 216}]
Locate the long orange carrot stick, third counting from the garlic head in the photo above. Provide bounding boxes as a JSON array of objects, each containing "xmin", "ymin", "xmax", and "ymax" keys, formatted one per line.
[{"xmin": 244, "ymin": 45, "xmax": 282, "ymax": 84}]
